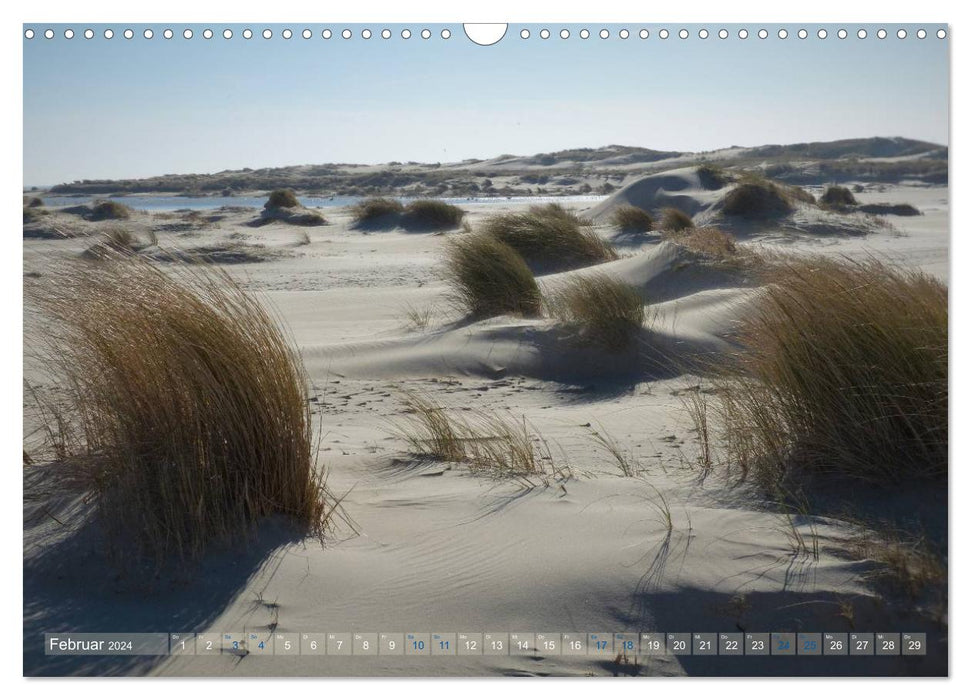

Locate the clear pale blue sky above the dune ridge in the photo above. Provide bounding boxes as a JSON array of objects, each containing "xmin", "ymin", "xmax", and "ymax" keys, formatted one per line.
[{"xmin": 23, "ymin": 24, "xmax": 949, "ymax": 186}]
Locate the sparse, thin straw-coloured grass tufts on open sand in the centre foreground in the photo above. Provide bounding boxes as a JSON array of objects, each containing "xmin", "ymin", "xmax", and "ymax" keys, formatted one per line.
[{"xmin": 393, "ymin": 391, "xmax": 569, "ymax": 486}]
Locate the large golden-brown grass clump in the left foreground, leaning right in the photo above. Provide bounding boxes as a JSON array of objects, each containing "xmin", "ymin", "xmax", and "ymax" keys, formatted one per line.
[{"xmin": 25, "ymin": 254, "xmax": 329, "ymax": 567}]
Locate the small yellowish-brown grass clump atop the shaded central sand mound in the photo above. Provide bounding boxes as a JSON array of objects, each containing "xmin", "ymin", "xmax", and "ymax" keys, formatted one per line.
[{"xmin": 546, "ymin": 273, "xmax": 646, "ymax": 350}]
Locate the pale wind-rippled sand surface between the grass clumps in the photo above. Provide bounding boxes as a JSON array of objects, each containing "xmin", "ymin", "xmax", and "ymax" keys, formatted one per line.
[{"xmin": 24, "ymin": 178, "xmax": 948, "ymax": 676}]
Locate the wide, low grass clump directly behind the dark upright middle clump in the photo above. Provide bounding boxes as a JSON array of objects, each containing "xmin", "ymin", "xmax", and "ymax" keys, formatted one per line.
[{"xmin": 482, "ymin": 204, "xmax": 617, "ymax": 272}]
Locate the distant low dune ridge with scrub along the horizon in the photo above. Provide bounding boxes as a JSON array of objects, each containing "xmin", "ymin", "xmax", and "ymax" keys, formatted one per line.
[{"xmin": 41, "ymin": 138, "xmax": 948, "ymax": 197}]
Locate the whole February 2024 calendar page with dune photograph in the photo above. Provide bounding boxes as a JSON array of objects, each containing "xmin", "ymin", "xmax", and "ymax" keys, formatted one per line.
[{"xmin": 20, "ymin": 22, "xmax": 951, "ymax": 678}]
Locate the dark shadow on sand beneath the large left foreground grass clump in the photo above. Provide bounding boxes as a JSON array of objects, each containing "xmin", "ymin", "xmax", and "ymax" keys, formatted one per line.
[{"xmin": 23, "ymin": 468, "xmax": 316, "ymax": 676}]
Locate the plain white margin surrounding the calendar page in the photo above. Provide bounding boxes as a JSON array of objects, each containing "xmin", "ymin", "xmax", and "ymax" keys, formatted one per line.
[{"xmin": 0, "ymin": 0, "xmax": 971, "ymax": 700}]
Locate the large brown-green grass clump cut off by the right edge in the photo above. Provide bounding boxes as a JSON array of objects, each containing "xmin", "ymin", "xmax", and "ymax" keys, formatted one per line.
[{"xmin": 700, "ymin": 259, "xmax": 948, "ymax": 485}]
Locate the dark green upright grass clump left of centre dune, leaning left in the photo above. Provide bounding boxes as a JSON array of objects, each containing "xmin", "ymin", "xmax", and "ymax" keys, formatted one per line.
[{"xmin": 445, "ymin": 233, "xmax": 542, "ymax": 318}]
